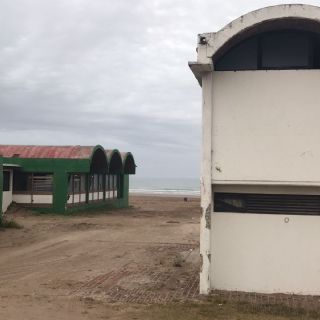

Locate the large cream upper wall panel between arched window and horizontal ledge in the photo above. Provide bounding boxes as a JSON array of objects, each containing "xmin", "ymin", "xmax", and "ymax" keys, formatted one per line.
[{"xmin": 212, "ymin": 70, "xmax": 320, "ymax": 185}]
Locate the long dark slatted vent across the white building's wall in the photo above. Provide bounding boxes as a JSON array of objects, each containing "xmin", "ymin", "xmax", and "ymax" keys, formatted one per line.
[{"xmin": 214, "ymin": 192, "xmax": 320, "ymax": 215}]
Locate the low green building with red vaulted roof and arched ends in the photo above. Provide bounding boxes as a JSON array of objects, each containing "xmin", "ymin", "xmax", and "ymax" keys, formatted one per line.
[{"xmin": 0, "ymin": 145, "xmax": 136, "ymax": 213}]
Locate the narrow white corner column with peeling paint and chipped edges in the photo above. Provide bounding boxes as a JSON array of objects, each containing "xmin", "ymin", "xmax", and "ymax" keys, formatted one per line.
[{"xmin": 200, "ymin": 72, "xmax": 213, "ymax": 294}]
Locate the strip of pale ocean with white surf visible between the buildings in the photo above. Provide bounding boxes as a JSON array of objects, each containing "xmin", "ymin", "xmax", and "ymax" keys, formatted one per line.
[{"xmin": 129, "ymin": 176, "xmax": 200, "ymax": 197}]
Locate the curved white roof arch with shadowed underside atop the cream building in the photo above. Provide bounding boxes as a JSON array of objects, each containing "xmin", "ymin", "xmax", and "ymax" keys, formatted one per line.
[{"xmin": 205, "ymin": 4, "xmax": 320, "ymax": 60}]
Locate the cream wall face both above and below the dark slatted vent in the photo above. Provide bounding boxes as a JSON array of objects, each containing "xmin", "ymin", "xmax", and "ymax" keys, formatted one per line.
[{"xmin": 210, "ymin": 70, "xmax": 320, "ymax": 294}]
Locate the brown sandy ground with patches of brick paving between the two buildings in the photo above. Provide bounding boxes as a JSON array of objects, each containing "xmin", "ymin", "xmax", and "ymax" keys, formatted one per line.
[{"xmin": 0, "ymin": 196, "xmax": 200, "ymax": 320}]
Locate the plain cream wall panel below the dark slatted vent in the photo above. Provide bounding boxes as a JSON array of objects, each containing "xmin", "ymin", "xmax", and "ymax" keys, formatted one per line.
[{"xmin": 211, "ymin": 213, "xmax": 320, "ymax": 295}]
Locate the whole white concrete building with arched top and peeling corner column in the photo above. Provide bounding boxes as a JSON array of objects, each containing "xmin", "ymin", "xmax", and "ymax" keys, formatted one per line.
[{"xmin": 189, "ymin": 4, "xmax": 320, "ymax": 295}]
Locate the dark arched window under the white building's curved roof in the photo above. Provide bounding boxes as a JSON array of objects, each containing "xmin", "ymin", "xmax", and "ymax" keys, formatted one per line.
[{"xmin": 215, "ymin": 30, "xmax": 320, "ymax": 71}]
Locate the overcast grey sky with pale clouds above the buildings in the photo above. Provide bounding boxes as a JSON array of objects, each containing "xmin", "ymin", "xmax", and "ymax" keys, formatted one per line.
[{"xmin": 0, "ymin": 0, "xmax": 319, "ymax": 177}]
